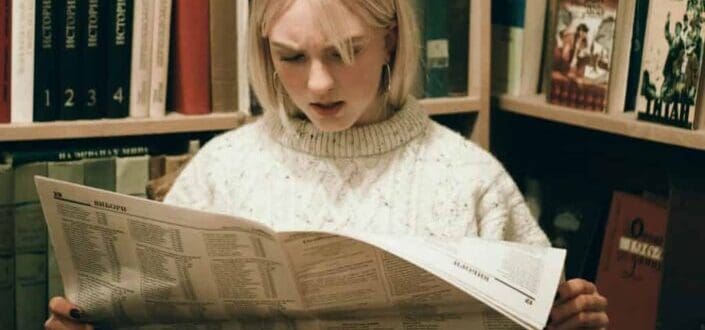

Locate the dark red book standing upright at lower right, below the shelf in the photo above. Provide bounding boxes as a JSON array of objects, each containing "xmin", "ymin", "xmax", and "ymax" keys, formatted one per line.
[{"xmin": 596, "ymin": 192, "xmax": 668, "ymax": 329}]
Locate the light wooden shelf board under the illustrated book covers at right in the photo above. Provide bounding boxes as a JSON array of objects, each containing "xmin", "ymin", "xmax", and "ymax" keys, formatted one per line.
[{"xmin": 497, "ymin": 95, "xmax": 705, "ymax": 150}]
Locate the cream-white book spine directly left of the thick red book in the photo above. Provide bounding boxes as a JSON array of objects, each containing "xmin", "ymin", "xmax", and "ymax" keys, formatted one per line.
[{"xmin": 149, "ymin": 0, "xmax": 171, "ymax": 118}]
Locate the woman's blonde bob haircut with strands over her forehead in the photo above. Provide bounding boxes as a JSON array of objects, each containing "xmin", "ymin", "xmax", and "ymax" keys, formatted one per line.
[{"xmin": 247, "ymin": 0, "xmax": 419, "ymax": 114}]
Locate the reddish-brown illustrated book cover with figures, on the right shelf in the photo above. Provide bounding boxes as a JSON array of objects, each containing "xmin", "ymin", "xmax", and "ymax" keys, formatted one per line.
[{"xmin": 548, "ymin": 0, "xmax": 618, "ymax": 111}]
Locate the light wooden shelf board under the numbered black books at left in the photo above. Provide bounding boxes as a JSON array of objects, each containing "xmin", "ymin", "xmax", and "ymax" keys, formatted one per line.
[{"xmin": 0, "ymin": 112, "xmax": 245, "ymax": 141}]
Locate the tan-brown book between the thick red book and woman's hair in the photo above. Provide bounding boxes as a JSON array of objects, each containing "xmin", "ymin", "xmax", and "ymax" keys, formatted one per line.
[{"xmin": 208, "ymin": 0, "xmax": 239, "ymax": 112}]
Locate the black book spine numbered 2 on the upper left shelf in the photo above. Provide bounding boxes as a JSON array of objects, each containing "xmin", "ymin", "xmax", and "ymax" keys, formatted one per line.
[{"xmin": 59, "ymin": 0, "xmax": 84, "ymax": 120}]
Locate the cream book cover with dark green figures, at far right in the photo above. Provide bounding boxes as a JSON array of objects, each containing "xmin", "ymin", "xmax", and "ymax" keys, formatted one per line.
[{"xmin": 636, "ymin": 0, "xmax": 705, "ymax": 129}]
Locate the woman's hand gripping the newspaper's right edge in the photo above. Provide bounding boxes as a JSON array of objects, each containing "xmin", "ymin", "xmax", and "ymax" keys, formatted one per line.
[{"xmin": 548, "ymin": 278, "xmax": 609, "ymax": 330}]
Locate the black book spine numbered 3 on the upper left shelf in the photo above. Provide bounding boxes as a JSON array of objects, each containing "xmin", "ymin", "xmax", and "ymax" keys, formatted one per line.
[{"xmin": 80, "ymin": 0, "xmax": 109, "ymax": 119}]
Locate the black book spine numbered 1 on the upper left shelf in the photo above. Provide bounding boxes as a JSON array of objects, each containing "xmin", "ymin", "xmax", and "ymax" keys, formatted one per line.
[{"xmin": 33, "ymin": 0, "xmax": 60, "ymax": 122}]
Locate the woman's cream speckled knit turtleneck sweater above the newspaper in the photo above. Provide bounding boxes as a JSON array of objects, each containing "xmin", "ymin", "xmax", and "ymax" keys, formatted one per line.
[{"xmin": 165, "ymin": 100, "xmax": 548, "ymax": 245}]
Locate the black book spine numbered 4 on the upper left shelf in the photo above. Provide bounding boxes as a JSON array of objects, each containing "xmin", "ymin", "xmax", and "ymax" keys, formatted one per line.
[{"xmin": 105, "ymin": 0, "xmax": 134, "ymax": 118}]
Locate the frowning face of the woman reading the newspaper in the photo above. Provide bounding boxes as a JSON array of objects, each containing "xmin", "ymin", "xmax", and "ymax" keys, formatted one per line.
[{"xmin": 269, "ymin": 0, "xmax": 389, "ymax": 132}]
